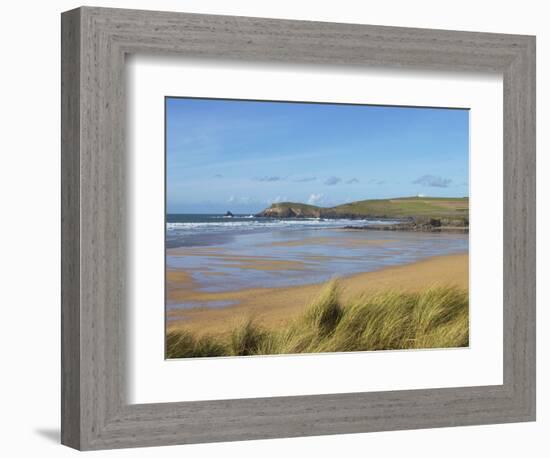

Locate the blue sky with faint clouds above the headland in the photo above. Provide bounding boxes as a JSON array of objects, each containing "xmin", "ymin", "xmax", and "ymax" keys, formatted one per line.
[{"xmin": 166, "ymin": 98, "xmax": 469, "ymax": 213}]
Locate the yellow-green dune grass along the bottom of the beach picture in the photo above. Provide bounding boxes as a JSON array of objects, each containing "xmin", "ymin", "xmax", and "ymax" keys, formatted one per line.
[{"xmin": 166, "ymin": 281, "xmax": 469, "ymax": 359}]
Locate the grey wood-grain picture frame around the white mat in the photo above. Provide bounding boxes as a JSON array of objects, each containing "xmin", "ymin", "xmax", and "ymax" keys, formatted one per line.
[{"xmin": 61, "ymin": 7, "xmax": 535, "ymax": 450}]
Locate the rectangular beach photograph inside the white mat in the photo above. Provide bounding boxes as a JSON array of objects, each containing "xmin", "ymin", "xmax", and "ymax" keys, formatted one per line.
[{"xmin": 165, "ymin": 97, "xmax": 470, "ymax": 359}]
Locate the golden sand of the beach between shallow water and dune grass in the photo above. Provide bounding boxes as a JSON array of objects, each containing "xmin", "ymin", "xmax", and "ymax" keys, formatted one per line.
[{"xmin": 167, "ymin": 254, "xmax": 469, "ymax": 334}]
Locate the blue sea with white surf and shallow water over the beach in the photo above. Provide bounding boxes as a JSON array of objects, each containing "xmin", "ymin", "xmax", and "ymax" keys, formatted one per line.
[{"xmin": 166, "ymin": 214, "xmax": 469, "ymax": 308}]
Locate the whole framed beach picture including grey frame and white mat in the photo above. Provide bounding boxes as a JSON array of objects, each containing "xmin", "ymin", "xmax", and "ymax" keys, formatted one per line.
[{"xmin": 62, "ymin": 7, "xmax": 535, "ymax": 450}]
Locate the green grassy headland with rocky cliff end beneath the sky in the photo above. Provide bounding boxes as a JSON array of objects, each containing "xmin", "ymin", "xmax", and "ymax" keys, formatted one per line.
[{"xmin": 257, "ymin": 197, "xmax": 469, "ymax": 224}]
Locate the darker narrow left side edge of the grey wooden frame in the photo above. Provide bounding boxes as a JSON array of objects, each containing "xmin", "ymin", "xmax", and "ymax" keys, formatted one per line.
[{"xmin": 61, "ymin": 7, "xmax": 81, "ymax": 448}]
